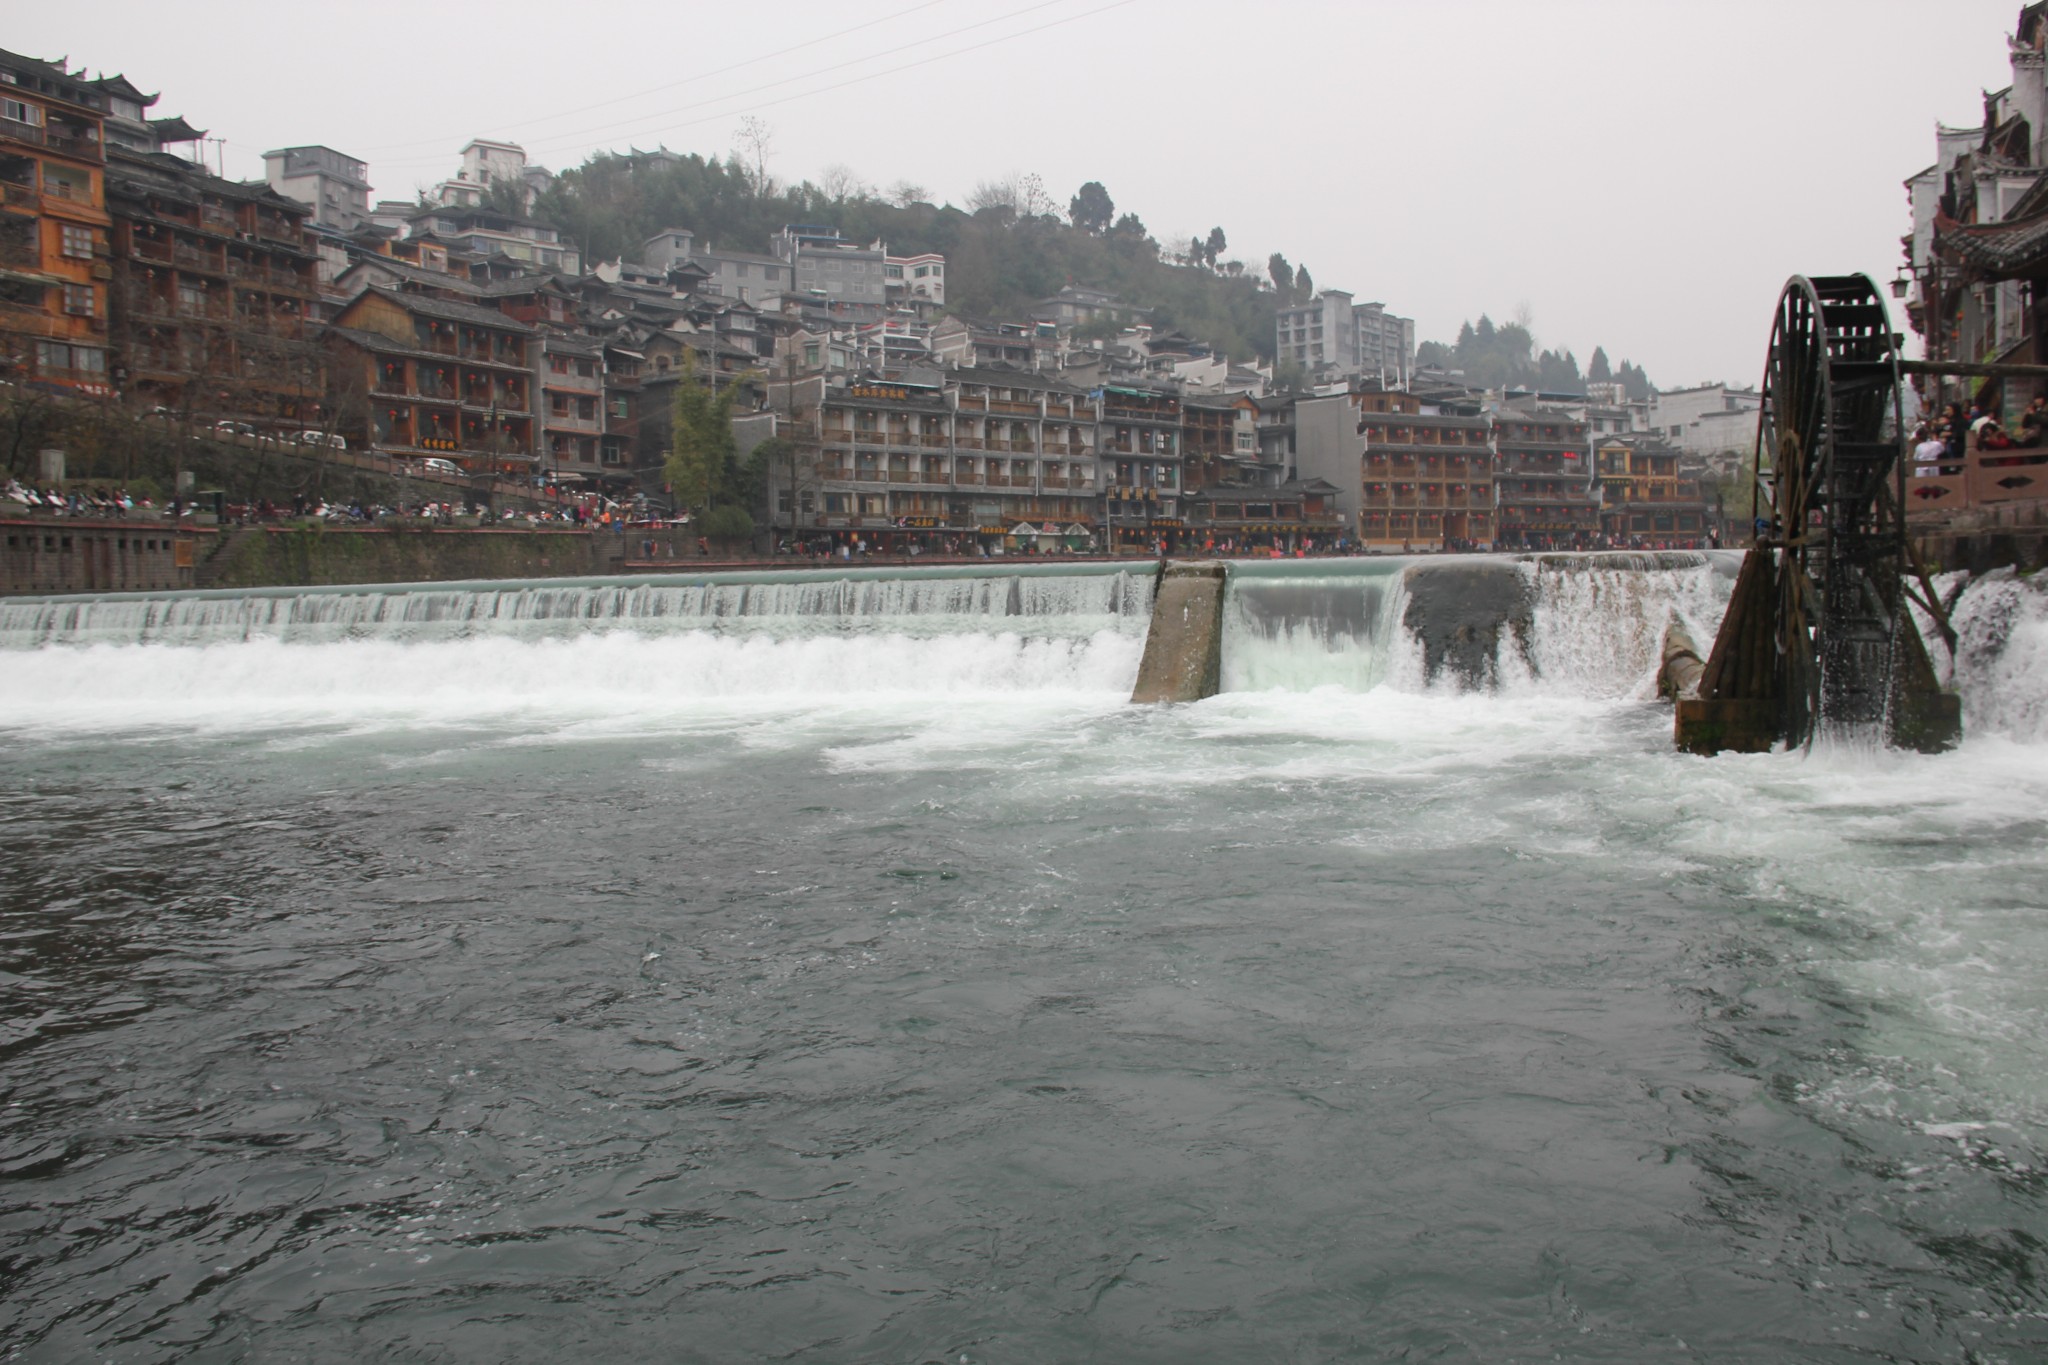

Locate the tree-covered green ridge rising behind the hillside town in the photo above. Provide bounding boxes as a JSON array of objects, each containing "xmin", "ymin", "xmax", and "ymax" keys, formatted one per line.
[{"xmin": 535, "ymin": 147, "xmax": 1649, "ymax": 391}]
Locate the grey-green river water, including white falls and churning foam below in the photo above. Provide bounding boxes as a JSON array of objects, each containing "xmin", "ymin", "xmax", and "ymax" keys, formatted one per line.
[{"xmin": 0, "ymin": 557, "xmax": 2048, "ymax": 1363}]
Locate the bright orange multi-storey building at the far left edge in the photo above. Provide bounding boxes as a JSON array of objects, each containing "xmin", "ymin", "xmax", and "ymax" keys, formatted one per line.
[{"xmin": 0, "ymin": 51, "xmax": 113, "ymax": 395}]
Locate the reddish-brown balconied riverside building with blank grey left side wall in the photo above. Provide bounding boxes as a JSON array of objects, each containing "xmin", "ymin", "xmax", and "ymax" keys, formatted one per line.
[{"xmin": 1294, "ymin": 387, "xmax": 1497, "ymax": 551}]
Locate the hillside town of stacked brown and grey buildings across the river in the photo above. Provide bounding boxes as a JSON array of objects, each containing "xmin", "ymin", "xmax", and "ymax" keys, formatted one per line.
[{"xmin": 0, "ymin": 38, "xmax": 1757, "ymax": 577}]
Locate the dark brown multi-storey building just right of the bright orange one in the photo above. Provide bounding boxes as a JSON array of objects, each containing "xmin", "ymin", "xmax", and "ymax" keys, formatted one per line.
[{"xmin": 106, "ymin": 149, "xmax": 322, "ymax": 428}]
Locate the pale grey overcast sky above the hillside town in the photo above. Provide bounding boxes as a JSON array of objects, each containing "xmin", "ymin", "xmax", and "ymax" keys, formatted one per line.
[{"xmin": 12, "ymin": 0, "xmax": 2019, "ymax": 387}]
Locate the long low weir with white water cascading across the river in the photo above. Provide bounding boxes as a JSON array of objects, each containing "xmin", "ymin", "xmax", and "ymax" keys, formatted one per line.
[{"xmin": 0, "ymin": 553, "xmax": 2048, "ymax": 747}]
